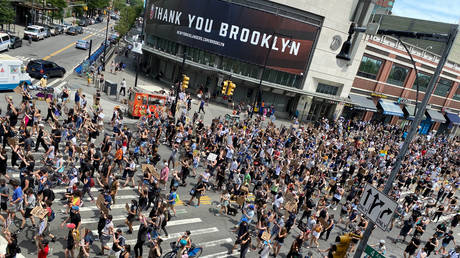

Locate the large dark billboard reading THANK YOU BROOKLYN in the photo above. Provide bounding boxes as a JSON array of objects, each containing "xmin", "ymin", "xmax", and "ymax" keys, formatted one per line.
[{"xmin": 145, "ymin": 0, "xmax": 319, "ymax": 74}]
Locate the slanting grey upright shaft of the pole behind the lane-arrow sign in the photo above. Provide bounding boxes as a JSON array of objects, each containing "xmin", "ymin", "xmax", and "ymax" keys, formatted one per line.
[{"xmin": 353, "ymin": 25, "xmax": 458, "ymax": 258}]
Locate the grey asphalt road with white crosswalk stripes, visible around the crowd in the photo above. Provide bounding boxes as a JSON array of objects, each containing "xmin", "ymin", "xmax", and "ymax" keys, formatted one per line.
[{"xmin": 0, "ymin": 19, "xmax": 460, "ymax": 257}]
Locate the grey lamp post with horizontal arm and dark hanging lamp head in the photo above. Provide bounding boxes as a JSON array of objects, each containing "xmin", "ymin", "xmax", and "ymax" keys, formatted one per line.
[{"xmin": 336, "ymin": 24, "xmax": 458, "ymax": 258}]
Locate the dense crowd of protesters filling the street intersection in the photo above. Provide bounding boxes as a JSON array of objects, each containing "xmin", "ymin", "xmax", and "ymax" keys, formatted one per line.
[{"xmin": 0, "ymin": 82, "xmax": 454, "ymax": 258}]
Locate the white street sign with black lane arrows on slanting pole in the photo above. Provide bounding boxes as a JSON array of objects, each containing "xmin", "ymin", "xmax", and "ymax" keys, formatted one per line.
[{"xmin": 358, "ymin": 184, "xmax": 398, "ymax": 230}]
